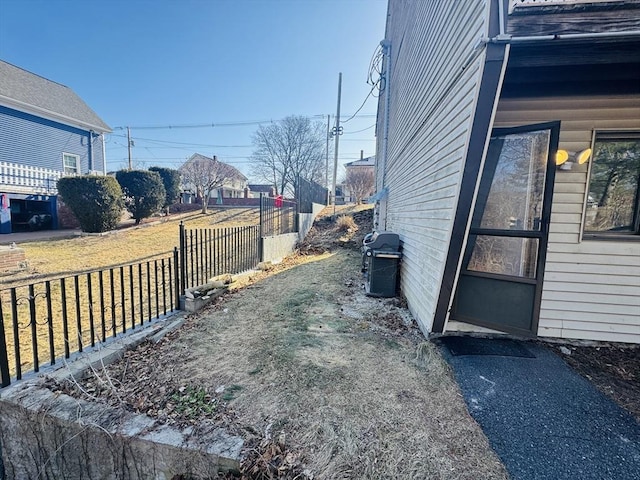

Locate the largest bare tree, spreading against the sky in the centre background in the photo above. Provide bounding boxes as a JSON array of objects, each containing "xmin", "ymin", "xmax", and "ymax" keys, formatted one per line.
[{"xmin": 251, "ymin": 115, "xmax": 326, "ymax": 194}]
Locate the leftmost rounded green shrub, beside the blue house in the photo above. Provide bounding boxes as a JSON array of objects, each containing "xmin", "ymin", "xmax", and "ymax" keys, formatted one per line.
[{"xmin": 58, "ymin": 175, "xmax": 124, "ymax": 233}]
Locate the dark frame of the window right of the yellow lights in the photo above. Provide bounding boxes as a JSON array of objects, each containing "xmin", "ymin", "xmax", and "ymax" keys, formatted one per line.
[{"xmin": 582, "ymin": 130, "xmax": 640, "ymax": 242}]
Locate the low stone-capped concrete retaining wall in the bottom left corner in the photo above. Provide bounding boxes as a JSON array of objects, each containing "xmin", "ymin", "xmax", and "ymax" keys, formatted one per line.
[{"xmin": 0, "ymin": 319, "xmax": 243, "ymax": 480}]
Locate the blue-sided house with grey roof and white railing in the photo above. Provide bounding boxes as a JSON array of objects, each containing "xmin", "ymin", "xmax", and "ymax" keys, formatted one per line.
[{"xmin": 0, "ymin": 60, "xmax": 111, "ymax": 233}]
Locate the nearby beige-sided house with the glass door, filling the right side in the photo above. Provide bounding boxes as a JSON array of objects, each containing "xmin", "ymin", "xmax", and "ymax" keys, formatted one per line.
[{"xmin": 375, "ymin": 0, "xmax": 640, "ymax": 343}]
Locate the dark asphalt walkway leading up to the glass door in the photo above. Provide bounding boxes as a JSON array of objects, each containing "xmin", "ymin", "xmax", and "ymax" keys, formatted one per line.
[{"xmin": 439, "ymin": 337, "xmax": 640, "ymax": 480}]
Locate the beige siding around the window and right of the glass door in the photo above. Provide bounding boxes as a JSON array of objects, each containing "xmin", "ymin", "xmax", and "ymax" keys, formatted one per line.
[{"xmin": 495, "ymin": 97, "xmax": 640, "ymax": 343}]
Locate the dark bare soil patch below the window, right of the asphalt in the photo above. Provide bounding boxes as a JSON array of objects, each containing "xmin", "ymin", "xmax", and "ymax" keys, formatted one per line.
[{"xmin": 546, "ymin": 344, "xmax": 640, "ymax": 422}]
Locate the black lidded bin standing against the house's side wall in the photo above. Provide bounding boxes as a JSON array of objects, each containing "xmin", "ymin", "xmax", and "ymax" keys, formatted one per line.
[{"xmin": 362, "ymin": 232, "xmax": 402, "ymax": 297}]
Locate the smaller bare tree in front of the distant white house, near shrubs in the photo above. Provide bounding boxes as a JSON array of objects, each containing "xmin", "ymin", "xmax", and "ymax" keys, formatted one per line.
[{"xmin": 179, "ymin": 153, "xmax": 243, "ymax": 213}]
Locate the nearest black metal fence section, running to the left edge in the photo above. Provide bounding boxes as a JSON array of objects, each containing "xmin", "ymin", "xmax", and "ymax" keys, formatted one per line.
[{"xmin": 0, "ymin": 255, "xmax": 179, "ymax": 387}]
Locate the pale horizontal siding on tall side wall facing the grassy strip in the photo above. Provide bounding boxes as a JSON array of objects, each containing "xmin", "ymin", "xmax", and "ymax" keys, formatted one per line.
[{"xmin": 377, "ymin": 0, "xmax": 487, "ymax": 331}]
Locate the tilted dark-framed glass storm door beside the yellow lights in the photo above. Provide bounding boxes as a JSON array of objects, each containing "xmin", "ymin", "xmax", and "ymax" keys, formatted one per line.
[{"xmin": 450, "ymin": 122, "xmax": 560, "ymax": 336}]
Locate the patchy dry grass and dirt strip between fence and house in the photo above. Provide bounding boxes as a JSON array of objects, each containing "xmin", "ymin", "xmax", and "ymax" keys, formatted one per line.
[{"xmin": 47, "ymin": 207, "xmax": 506, "ymax": 479}]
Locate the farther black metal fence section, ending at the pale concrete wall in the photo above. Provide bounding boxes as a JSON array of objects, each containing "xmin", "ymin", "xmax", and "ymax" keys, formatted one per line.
[{"xmin": 180, "ymin": 224, "xmax": 261, "ymax": 292}]
